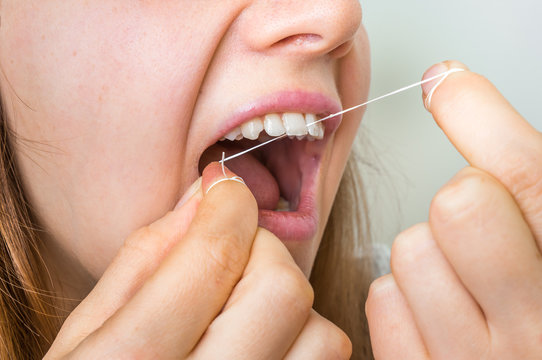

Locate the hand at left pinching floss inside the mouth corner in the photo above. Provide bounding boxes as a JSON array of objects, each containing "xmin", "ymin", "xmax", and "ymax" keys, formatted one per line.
[{"xmin": 45, "ymin": 163, "xmax": 351, "ymax": 359}]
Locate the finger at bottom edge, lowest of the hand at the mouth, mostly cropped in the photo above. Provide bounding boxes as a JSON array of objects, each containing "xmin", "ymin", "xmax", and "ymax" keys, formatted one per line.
[{"xmin": 284, "ymin": 310, "xmax": 352, "ymax": 360}]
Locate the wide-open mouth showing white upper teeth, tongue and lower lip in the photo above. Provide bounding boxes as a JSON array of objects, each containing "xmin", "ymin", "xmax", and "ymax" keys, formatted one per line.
[{"xmin": 198, "ymin": 92, "xmax": 340, "ymax": 241}]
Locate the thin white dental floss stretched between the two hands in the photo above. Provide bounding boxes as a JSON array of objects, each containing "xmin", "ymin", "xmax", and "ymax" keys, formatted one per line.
[{"xmin": 219, "ymin": 68, "xmax": 465, "ymax": 163}]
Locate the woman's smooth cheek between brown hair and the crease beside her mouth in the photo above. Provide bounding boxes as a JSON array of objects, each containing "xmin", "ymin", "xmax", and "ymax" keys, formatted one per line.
[{"xmin": 0, "ymin": 0, "xmax": 234, "ymax": 276}]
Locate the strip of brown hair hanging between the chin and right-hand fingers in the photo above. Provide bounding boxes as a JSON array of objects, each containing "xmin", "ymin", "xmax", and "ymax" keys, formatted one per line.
[{"xmin": 311, "ymin": 141, "xmax": 374, "ymax": 360}]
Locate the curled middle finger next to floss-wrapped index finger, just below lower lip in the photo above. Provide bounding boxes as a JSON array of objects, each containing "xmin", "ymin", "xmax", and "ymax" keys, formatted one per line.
[{"xmin": 191, "ymin": 228, "xmax": 314, "ymax": 359}]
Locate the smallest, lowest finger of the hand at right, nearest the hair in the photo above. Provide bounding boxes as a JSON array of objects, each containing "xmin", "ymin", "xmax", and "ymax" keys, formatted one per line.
[{"xmin": 365, "ymin": 275, "xmax": 429, "ymax": 360}]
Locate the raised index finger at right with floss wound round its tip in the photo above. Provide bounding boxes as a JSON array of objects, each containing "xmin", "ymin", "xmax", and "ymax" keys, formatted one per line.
[{"xmin": 424, "ymin": 62, "xmax": 542, "ymax": 240}]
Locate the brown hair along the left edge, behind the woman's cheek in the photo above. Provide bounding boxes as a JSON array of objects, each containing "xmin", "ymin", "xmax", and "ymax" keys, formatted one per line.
[{"xmin": 0, "ymin": 95, "xmax": 60, "ymax": 359}]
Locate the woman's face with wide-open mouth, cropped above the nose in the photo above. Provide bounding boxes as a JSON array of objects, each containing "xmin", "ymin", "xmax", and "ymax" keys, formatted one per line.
[{"xmin": 0, "ymin": 0, "xmax": 369, "ymax": 288}]
